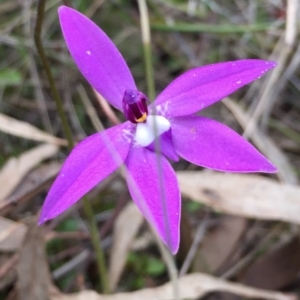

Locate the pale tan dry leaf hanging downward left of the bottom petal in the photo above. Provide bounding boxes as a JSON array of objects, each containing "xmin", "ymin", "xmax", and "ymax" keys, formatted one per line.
[{"xmin": 108, "ymin": 203, "xmax": 144, "ymax": 290}]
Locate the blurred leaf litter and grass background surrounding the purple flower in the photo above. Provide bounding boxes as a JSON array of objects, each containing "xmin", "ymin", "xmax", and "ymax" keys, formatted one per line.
[{"xmin": 0, "ymin": 0, "xmax": 300, "ymax": 300}]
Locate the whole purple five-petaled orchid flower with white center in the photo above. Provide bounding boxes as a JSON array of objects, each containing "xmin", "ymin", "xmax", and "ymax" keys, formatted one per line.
[{"xmin": 40, "ymin": 6, "xmax": 276, "ymax": 253}]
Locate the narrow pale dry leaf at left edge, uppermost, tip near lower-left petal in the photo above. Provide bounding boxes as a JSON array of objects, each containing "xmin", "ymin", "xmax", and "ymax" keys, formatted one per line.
[{"xmin": 0, "ymin": 113, "xmax": 67, "ymax": 146}]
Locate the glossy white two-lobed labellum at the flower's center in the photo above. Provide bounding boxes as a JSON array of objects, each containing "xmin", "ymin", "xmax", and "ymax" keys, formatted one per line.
[{"xmin": 134, "ymin": 115, "xmax": 171, "ymax": 147}]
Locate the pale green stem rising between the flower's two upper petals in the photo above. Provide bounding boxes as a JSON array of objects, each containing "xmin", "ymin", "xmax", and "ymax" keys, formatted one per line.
[{"xmin": 138, "ymin": 0, "xmax": 156, "ymax": 100}]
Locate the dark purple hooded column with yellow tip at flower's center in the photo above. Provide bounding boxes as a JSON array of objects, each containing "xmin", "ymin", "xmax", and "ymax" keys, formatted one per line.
[{"xmin": 123, "ymin": 90, "xmax": 148, "ymax": 124}]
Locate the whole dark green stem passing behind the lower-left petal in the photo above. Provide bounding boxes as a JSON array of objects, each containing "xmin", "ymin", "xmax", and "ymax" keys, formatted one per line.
[{"xmin": 34, "ymin": 0, "xmax": 109, "ymax": 293}]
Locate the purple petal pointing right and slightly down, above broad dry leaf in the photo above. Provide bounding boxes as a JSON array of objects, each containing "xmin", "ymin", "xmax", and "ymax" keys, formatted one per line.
[{"xmin": 171, "ymin": 116, "xmax": 277, "ymax": 173}]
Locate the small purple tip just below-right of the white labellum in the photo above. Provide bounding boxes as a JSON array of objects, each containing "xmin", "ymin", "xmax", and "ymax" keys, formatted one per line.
[{"xmin": 146, "ymin": 129, "xmax": 179, "ymax": 161}]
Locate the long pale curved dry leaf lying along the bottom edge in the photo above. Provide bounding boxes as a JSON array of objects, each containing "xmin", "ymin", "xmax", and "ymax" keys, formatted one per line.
[{"xmin": 51, "ymin": 273, "xmax": 296, "ymax": 300}]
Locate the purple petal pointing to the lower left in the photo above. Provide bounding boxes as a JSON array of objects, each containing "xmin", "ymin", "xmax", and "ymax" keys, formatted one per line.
[{"xmin": 39, "ymin": 122, "xmax": 131, "ymax": 224}]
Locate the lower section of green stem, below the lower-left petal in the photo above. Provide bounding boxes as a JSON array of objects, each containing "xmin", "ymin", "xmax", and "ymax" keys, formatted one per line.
[{"xmin": 83, "ymin": 198, "xmax": 110, "ymax": 294}]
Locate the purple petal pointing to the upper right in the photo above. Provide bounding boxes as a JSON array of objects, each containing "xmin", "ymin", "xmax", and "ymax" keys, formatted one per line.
[{"xmin": 152, "ymin": 59, "xmax": 276, "ymax": 117}]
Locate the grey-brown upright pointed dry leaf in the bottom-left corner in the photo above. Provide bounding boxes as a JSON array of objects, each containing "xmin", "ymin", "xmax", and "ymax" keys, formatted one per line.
[{"xmin": 17, "ymin": 218, "xmax": 56, "ymax": 300}]
